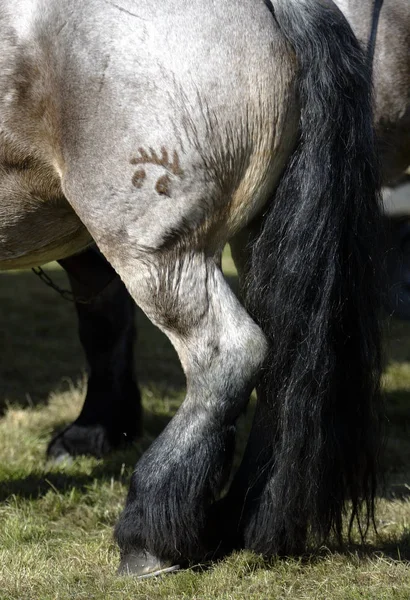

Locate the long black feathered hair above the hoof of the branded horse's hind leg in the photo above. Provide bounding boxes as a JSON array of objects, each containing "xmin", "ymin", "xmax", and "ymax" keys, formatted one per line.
[{"xmin": 116, "ymin": 412, "xmax": 235, "ymax": 564}]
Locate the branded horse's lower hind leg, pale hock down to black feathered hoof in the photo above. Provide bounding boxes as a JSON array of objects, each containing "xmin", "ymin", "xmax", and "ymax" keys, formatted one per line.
[{"xmin": 107, "ymin": 250, "xmax": 266, "ymax": 575}]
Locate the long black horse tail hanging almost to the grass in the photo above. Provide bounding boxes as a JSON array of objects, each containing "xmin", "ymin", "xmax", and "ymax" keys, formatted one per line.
[{"xmin": 247, "ymin": 0, "xmax": 381, "ymax": 552}]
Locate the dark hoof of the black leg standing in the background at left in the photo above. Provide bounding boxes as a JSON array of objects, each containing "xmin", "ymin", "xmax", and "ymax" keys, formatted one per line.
[{"xmin": 47, "ymin": 424, "xmax": 120, "ymax": 462}]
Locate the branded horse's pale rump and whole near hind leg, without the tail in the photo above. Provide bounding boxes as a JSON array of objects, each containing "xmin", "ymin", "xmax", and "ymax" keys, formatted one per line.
[{"xmin": 53, "ymin": 0, "xmax": 298, "ymax": 574}]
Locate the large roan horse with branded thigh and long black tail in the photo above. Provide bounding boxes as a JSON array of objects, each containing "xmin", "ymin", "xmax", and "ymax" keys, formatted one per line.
[{"xmin": 0, "ymin": 0, "xmax": 381, "ymax": 576}]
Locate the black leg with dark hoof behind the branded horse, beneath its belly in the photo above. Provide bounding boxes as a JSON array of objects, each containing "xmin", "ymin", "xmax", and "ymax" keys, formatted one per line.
[{"xmin": 47, "ymin": 248, "xmax": 142, "ymax": 459}]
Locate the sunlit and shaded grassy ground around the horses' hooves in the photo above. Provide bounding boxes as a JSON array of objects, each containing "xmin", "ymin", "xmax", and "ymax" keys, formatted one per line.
[{"xmin": 0, "ymin": 255, "xmax": 410, "ymax": 600}]
